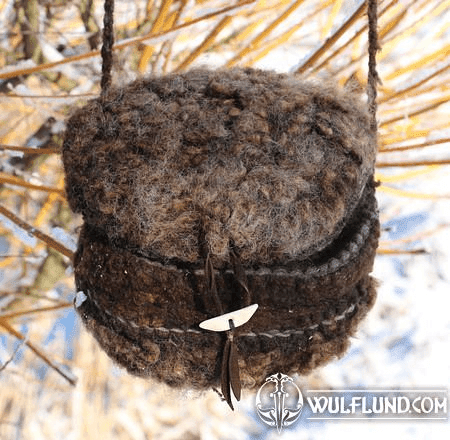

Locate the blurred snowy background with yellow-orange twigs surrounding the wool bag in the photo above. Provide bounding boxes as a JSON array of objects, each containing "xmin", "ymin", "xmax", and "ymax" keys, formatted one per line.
[{"xmin": 0, "ymin": 0, "xmax": 450, "ymax": 440}]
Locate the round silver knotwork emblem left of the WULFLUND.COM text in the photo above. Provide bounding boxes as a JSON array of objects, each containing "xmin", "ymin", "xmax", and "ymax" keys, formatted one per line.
[{"xmin": 256, "ymin": 373, "xmax": 303, "ymax": 433}]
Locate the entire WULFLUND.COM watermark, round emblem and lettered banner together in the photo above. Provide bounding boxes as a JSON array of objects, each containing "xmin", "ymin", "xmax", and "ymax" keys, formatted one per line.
[{"xmin": 255, "ymin": 373, "xmax": 448, "ymax": 433}]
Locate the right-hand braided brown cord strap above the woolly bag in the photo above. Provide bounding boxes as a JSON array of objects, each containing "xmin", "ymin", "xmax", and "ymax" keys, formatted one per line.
[{"xmin": 367, "ymin": 0, "xmax": 381, "ymax": 134}]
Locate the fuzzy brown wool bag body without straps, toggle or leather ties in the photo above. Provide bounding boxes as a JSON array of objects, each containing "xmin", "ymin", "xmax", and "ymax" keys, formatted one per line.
[{"xmin": 63, "ymin": 69, "xmax": 379, "ymax": 389}]
